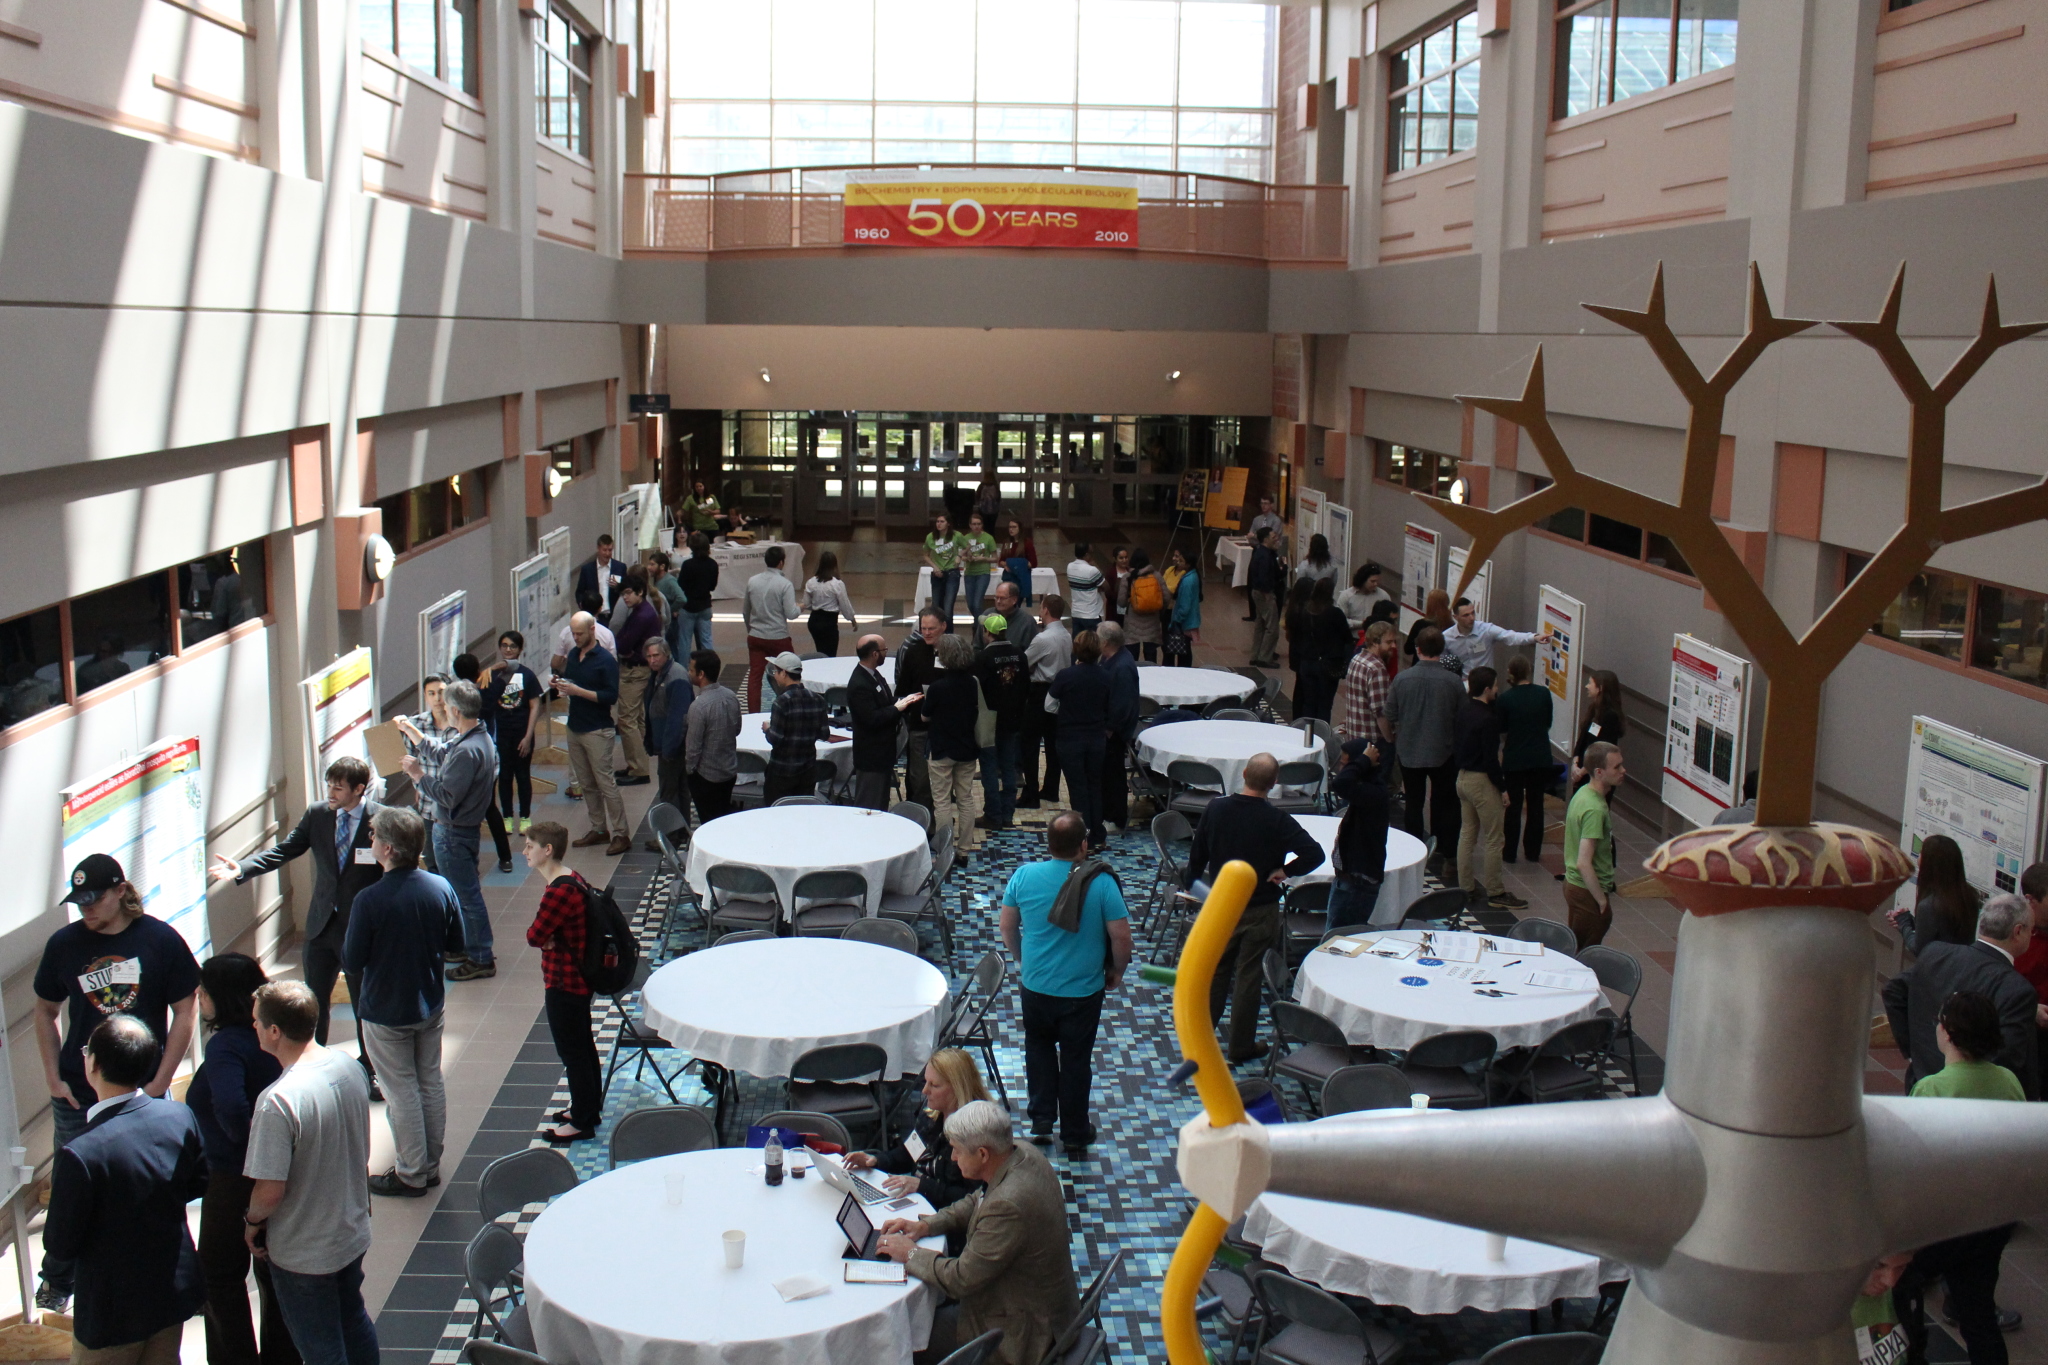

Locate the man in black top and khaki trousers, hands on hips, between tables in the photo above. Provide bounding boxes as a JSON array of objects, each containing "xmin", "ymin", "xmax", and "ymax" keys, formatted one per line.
[{"xmin": 1188, "ymin": 753, "xmax": 1323, "ymax": 1062}]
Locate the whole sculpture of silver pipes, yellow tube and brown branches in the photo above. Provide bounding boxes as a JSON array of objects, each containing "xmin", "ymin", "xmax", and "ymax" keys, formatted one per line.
[{"xmin": 1161, "ymin": 266, "xmax": 2048, "ymax": 1365}]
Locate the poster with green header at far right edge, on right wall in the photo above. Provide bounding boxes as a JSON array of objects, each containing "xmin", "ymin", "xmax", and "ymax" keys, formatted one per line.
[{"xmin": 1901, "ymin": 716, "xmax": 2048, "ymax": 898}]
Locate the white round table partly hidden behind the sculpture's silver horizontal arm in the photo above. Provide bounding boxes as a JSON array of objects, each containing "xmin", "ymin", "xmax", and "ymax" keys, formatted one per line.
[{"xmin": 1245, "ymin": 1109, "xmax": 1628, "ymax": 1314}]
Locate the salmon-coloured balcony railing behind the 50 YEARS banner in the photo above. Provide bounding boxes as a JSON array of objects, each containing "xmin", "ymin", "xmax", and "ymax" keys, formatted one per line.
[{"xmin": 625, "ymin": 166, "xmax": 1346, "ymax": 262}]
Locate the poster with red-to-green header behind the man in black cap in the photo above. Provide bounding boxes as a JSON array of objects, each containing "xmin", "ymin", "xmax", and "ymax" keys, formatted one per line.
[{"xmin": 61, "ymin": 735, "xmax": 213, "ymax": 961}]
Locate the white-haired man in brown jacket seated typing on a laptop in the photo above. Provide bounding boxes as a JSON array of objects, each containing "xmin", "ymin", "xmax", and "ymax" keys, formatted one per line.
[{"xmin": 881, "ymin": 1099, "xmax": 1079, "ymax": 1365}]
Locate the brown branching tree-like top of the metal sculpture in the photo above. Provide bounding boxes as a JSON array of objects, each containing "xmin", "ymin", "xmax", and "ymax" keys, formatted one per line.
[{"xmin": 1417, "ymin": 264, "xmax": 2048, "ymax": 825}]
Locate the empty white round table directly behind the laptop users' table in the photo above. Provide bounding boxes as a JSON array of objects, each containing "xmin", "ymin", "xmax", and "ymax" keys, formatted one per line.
[{"xmin": 641, "ymin": 939, "xmax": 950, "ymax": 1076}]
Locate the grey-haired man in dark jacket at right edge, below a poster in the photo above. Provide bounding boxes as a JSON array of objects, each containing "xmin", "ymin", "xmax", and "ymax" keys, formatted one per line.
[{"xmin": 1884, "ymin": 896, "xmax": 2048, "ymax": 1099}]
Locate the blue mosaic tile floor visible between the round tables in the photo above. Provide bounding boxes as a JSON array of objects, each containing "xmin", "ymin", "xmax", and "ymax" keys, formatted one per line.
[{"xmin": 379, "ymin": 810, "xmax": 1663, "ymax": 1365}]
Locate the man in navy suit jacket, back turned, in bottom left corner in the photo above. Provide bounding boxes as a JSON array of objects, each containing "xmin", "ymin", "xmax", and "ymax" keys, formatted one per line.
[{"xmin": 43, "ymin": 1015, "xmax": 207, "ymax": 1365}]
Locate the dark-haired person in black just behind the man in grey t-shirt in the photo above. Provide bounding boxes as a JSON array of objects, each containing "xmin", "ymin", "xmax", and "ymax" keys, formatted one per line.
[{"xmin": 184, "ymin": 954, "xmax": 299, "ymax": 1365}]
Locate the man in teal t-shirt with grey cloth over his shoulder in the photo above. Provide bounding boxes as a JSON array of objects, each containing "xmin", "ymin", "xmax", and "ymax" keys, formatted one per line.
[{"xmin": 1001, "ymin": 810, "xmax": 1130, "ymax": 1158}]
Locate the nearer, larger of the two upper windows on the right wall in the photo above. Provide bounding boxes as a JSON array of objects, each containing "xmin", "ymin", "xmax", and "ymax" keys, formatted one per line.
[{"xmin": 1550, "ymin": 0, "xmax": 1737, "ymax": 119}]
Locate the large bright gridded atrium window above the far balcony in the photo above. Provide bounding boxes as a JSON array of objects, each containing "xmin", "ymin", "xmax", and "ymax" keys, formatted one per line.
[{"xmin": 670, "ymin": 0, "xmax": 1280, "ymax": 180}]
